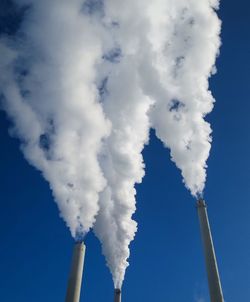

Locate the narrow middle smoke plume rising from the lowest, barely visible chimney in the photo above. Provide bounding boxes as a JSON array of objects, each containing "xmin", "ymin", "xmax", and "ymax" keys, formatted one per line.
[{"xmin": 94, "ymin": 1, "xmax": 153, "ymax": 288}]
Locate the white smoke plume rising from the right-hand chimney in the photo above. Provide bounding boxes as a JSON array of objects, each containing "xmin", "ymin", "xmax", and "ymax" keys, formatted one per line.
[{"xmin": 146, "ymin": 0, "xmax": 220, "ymax": 196}]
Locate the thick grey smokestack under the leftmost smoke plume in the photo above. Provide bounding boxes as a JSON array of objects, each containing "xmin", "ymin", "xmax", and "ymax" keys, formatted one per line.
[{"xmin": 65, "ymin": 242, "xmax": 85, "ymax": 302}]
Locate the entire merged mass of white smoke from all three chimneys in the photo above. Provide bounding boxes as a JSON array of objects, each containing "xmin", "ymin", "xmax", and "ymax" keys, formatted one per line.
[{"xmin": 0, "ymin": 0, "xmax": 220, "ymax": 288}]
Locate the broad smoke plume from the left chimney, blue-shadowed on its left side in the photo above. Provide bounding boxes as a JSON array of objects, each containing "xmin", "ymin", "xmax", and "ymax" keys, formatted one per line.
[{"xmin": 0, "ymin": 0, "xmax": 110, "ymax": 237}]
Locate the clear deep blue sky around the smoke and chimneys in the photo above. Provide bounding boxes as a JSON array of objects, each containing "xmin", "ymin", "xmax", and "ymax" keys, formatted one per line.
[{"xmin": 0, "ymin": 0, "xmax": 250, "ymax": 302}]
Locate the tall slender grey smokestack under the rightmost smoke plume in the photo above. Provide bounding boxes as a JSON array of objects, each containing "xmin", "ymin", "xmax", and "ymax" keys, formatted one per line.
[{"xmin": 197, "ymin": 199, "xmax": 224, "ymax": 302}]
